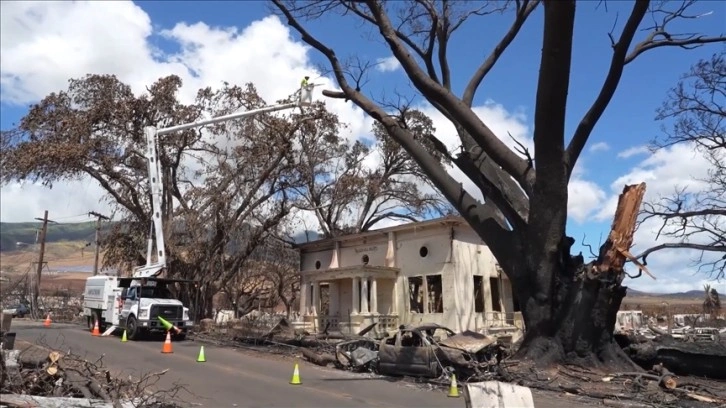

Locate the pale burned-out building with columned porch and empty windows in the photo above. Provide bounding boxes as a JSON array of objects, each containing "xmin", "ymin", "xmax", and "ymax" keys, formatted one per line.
[{"xmin": 297, "ymin": 216, "xmax": 522, "ymax": 334}]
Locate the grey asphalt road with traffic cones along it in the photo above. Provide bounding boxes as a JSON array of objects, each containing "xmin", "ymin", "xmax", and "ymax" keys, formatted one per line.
[{"xmin": 7, "ymin": 319, "xmax": 581, "ymax": 408}]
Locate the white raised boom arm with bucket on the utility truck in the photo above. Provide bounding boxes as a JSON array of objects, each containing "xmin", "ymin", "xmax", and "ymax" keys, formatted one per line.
[{"xmin": 133, "ymin": 84, "xmax": 315, "ymax": 278}]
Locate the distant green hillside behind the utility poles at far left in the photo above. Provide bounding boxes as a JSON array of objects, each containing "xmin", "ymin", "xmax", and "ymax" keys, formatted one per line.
[{"xmin": 0, "ymin": 221, "xmax": 101, "ymax": 251}]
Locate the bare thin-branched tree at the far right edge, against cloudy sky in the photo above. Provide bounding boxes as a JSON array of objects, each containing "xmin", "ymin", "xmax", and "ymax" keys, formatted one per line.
[{"xmin": 640, "ymin": 50, "xmax": 726, "ymax": 279}]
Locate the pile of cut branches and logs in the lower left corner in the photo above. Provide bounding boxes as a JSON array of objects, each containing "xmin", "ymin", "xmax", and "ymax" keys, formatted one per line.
[{"xmin": 0, "ymin": 345, "xmax": 182, "ymax": 408}]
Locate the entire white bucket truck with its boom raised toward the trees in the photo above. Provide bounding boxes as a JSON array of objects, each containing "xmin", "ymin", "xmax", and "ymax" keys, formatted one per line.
[{"xmin": 83, "ymin": 81, "xmax": 316, "ymax": 340}]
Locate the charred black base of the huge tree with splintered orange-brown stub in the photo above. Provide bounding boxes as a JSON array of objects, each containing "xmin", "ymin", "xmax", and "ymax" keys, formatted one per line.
[{"xmin": 512, "ymin": 184, "xmax": 647, "ymax": 369}]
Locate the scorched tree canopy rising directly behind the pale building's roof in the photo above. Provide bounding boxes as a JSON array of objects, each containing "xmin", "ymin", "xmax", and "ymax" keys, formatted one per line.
[{"xmin": 290, "ymin": 110, "xmax": 449, "ymax": 238}]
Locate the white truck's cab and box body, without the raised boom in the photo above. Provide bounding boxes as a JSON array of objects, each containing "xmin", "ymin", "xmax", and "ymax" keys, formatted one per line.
[{"xmin": 83, "ymin": 276, "xmax": 194, "ymax": 340}]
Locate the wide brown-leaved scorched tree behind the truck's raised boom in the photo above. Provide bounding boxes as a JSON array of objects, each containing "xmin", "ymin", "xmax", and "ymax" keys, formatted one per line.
[{"xmin": 2, "ymin": 75, "xmax": 338, "ymax": 318}]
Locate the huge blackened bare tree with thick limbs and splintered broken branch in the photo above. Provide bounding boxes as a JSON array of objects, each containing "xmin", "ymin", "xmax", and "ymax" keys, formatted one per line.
[{"xmin": 272, "ymin": 0, "xmax": 724, "ymax": 367}]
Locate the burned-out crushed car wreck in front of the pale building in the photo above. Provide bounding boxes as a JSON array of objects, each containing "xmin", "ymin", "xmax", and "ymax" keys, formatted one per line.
[{"xmin": 378, "ymin": 324, "xmax": 503, "ymax": 378}]
